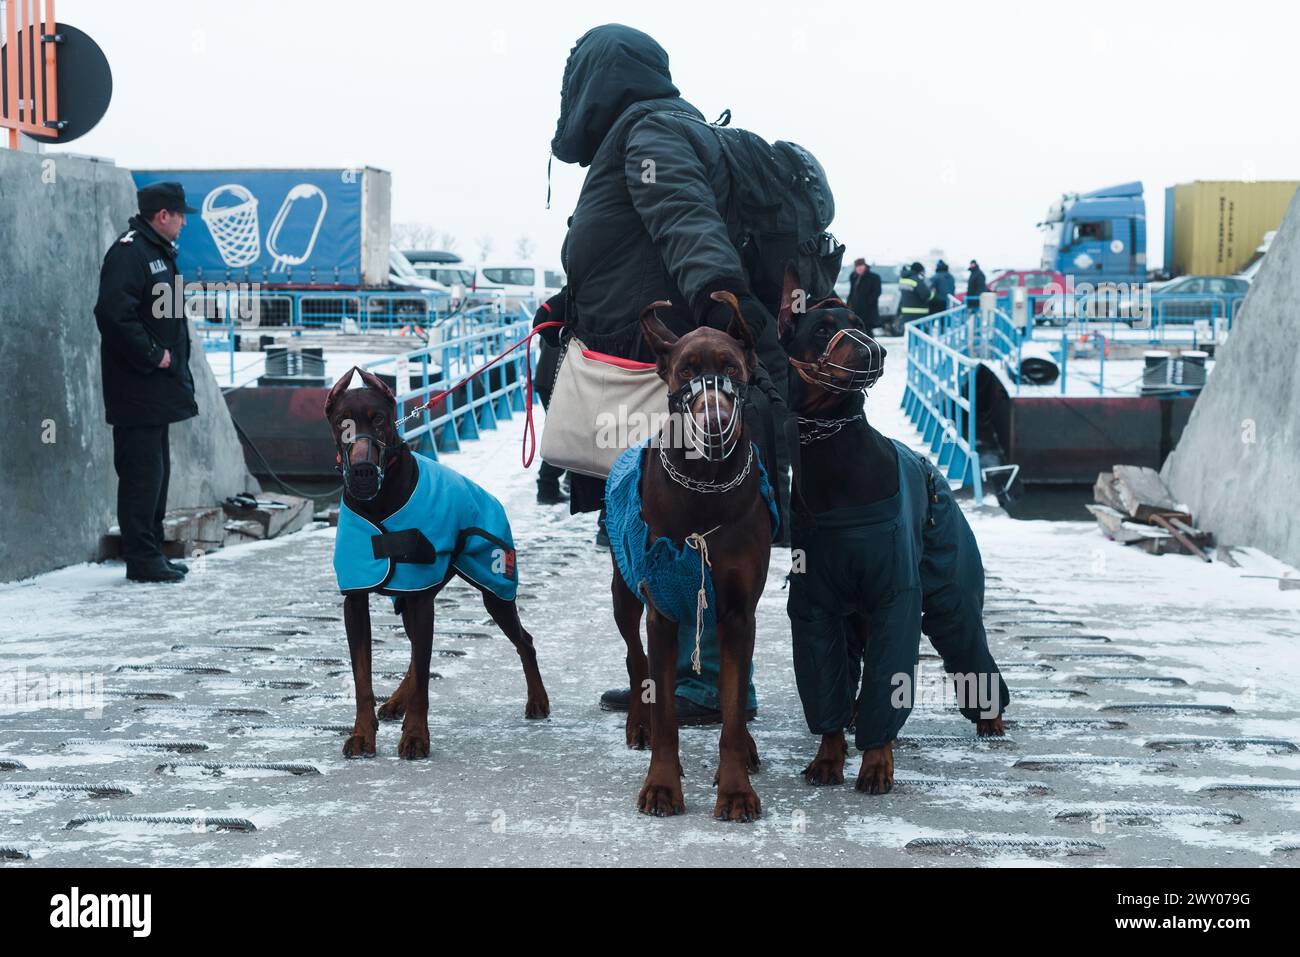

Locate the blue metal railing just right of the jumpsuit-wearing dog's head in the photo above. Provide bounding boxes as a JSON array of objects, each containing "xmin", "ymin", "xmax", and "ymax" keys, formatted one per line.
[{"xmin": 902, "ymin": 304, "xmax": 984, "ymax": 502}]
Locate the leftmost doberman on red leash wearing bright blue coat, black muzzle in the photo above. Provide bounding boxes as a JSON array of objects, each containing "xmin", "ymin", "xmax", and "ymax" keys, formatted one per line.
[{"xmin": 325, "ymin": 369, "xmax": 550, "ymax": 758}]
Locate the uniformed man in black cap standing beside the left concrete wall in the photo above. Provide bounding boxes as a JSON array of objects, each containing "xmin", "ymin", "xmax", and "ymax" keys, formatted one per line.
[{"xmin": 95, "ymin": 182, "xmax": 199, "ymax": 581}]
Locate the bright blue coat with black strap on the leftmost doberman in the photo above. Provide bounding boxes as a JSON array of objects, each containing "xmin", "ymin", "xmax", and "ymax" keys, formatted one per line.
[{"xmin": 334, "ymin": 452, "xmax": 519, "ymax": 601}]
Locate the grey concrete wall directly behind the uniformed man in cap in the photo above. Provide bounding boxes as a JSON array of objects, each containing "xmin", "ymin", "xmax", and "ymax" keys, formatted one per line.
[{"xmin": 0, "ymin": 150, "xmax": 257, "ymax": 581}]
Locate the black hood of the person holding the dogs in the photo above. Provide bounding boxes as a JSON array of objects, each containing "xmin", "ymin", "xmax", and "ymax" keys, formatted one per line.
[{"xmin": 551, "ymin": 23, "xmax": 679, "ymax": 166}]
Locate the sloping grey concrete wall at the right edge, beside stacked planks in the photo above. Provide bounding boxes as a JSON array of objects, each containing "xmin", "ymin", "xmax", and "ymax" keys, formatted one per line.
[{"xmin": 1161, "ymin": 194, "xmax": 1300, "ymax": 567}]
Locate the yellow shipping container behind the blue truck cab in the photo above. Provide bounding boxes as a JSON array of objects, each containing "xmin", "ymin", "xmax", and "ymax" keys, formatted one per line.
[{"xmin": 1165, "ymin": 179, "xmax": 1300, "ymax": 276}]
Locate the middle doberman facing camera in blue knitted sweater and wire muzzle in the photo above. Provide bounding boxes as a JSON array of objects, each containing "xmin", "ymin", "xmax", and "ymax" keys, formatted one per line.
[{"xmin": 606, "ymin": 293, "xmax": 774, "ymax": 820}]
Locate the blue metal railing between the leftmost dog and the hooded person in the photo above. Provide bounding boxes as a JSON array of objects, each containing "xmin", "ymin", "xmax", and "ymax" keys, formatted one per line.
[{"xmin": 365, "ymin": 306, "xmax": 536, "ymax": 458}]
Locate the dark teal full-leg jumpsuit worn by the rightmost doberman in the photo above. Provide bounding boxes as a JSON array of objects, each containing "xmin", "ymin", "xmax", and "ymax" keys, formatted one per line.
[{"xmin": 787, "ymin": 441, "xmax": 1010, "ymax": 750}]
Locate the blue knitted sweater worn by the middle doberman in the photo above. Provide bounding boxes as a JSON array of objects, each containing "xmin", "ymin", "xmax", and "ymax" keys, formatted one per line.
[{"xmin": 605, "ymin": 439, "xmax": 780, "ymax": 632}]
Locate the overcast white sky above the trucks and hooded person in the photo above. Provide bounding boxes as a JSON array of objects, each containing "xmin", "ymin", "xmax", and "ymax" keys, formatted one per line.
[{"xmin": 48, "ymin": 0, "xmax": 1300, "ymax": 267}]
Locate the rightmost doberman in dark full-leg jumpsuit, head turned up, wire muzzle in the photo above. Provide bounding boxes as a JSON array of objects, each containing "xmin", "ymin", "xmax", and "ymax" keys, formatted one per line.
[{"xmin": 777, "ymin": 270, "xmax": 1010, "ymax": 794}]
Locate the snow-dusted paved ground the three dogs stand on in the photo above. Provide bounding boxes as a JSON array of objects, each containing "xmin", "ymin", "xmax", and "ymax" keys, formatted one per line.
[{"xmin": 0, "ymin": 342, "xmax": 1300, "ymax": 867}]
